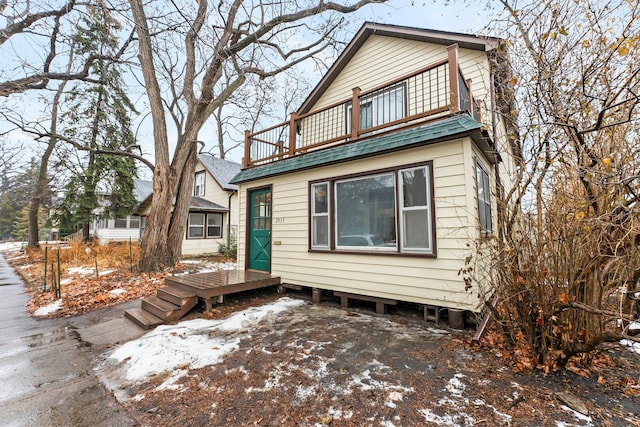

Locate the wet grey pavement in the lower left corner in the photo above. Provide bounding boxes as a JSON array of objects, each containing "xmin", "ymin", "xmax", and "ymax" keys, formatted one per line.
[{"xmin": 0, "ymin": 254, "xmax": 143, "ymax": 426}]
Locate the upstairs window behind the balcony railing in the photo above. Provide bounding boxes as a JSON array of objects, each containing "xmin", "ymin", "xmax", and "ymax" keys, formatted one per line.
[{"xmin": 346, "ymin": 84, "xmax": 406, "ymax": 133}]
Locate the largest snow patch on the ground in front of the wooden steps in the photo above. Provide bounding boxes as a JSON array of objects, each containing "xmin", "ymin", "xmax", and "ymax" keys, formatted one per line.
[{"xmin": 98, "ymin": 298, "xmax": 304, "ymax": 387}]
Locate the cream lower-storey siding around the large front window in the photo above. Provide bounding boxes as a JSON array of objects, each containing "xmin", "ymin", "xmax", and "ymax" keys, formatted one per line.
[{"xmin": 238, "ymin": 138, "xmax": 491, "ymax": 310}]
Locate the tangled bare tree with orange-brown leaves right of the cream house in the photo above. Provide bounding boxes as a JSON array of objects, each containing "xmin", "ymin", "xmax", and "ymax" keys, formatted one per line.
[{"xmin": 476, "ymin": 0, "xmax": 640, "ymax": 369}]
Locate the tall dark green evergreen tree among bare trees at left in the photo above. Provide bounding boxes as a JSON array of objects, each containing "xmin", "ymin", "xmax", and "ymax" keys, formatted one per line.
[{"xmin": 60, "ymin": 7, "xmax": 136, "ymax": 239}]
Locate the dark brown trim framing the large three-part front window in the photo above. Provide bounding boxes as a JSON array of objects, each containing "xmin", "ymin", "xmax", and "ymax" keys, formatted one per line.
[{"xmin": 307, "ymin": 160, "xmax": 438, "ymax": 258}]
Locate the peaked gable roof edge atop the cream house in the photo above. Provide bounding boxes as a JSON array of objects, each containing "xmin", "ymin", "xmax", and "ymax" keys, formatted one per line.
[{"xmin": 298, "ymin": 22, "xmax": 500, "ymax": 114}]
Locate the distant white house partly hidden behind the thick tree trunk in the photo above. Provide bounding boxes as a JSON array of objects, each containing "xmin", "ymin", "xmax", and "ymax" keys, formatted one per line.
[{"xmin": 89, "ymin": 179, "xmax": 153, "ymax": 242}]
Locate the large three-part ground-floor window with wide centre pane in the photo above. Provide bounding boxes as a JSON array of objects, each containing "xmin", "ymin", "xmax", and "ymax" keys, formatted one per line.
[{"xmin": 309, "ymin": 162, "xmax": 435, "ymax": 255}]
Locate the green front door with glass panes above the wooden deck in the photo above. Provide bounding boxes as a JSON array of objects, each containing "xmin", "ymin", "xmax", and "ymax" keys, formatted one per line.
[{"xmin": 248, "ymin": 188, "xmax": 271, "ymax": 271}]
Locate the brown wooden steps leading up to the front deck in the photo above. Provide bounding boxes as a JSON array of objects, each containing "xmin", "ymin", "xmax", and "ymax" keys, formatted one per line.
[{"xmin": 124, "ymin": 286, "xmax": 198, "ymax": 329}]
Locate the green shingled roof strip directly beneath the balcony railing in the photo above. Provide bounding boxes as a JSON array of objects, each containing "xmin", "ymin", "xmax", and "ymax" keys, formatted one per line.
[{"xmin": 230, "ymin": 114, "xmax": 495, "ymax": 184}]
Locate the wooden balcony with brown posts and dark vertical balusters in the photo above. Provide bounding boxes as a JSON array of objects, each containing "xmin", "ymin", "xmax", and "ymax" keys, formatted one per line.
[{"xmin": 243, "ymin": 45, "xmax": 480, "ymax": 169}]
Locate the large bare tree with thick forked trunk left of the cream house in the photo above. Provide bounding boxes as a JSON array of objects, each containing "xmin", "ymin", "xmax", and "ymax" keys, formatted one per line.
[{"xmin": 130, "ymin": 0, "xmax": 383, "ymax": 269}]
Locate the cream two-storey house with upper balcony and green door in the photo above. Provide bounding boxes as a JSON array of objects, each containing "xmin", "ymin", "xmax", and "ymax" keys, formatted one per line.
[{"xmin": 232, "ymin": 23, "xmax": 514, "ymax": 318}]
